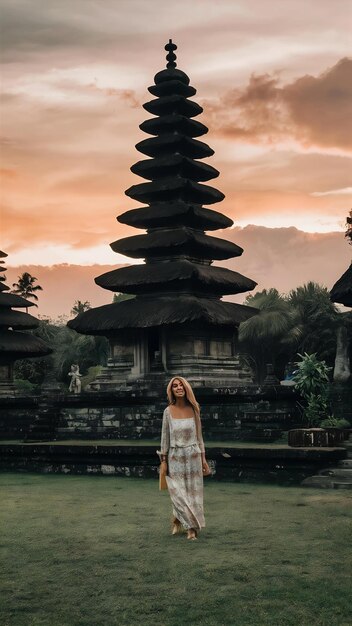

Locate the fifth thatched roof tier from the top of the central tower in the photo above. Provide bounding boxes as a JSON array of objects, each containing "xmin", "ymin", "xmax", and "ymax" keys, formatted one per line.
[{"xmin": 136, "ymin": 133, "xmax": 214, "ymax": 159}]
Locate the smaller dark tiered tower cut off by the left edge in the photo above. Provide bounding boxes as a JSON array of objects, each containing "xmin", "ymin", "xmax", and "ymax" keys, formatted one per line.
[{"xmin": 0, "ymin": 251, "xmax": 52, "ymax": 397}]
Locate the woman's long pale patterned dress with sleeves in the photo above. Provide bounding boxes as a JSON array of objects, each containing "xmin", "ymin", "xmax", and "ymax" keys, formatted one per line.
[{"xmin": 161, "ymin": 407, "xmax": 205, "ymax": 529}]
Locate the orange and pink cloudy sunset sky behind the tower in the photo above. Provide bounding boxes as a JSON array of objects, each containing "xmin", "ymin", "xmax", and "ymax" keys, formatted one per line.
[{"xmin": 0, "ymin": 0, "xmax": 352, "ymax": 314}]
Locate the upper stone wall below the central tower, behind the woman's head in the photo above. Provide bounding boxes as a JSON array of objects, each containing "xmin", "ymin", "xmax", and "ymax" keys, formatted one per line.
[{"xmin": 0, "ymin": 386, "xmax": 298, "ymax": 441}]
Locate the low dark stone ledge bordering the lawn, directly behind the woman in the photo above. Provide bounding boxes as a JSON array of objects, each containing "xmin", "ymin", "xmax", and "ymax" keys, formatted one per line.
[{"xmin": 0, "ymin": 440, "xmax": 347, "ymax": 488}]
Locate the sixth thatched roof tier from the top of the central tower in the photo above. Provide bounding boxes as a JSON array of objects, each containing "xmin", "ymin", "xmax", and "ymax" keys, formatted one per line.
[{"xmin": 131, "ymin": 154, "xmax": 219, "ymax": 181}]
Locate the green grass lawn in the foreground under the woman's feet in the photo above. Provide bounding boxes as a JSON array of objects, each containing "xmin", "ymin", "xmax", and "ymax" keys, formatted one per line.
[{"xmin": 0, "ymin": 473, "xmax": 352, "ymax": 626}]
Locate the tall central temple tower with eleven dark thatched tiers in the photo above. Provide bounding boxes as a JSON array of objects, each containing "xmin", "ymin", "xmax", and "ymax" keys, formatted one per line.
[{"xmin": 68, "ymin": 40, "xmax": 257, "ymax": 389}]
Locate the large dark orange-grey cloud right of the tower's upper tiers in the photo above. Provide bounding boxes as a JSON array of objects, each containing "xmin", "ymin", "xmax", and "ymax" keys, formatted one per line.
[{"xmin": 205, "ymin": 58, "xmax": 352, "ymax": 150}]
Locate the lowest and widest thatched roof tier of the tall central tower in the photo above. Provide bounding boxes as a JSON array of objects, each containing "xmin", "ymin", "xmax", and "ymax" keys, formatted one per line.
[{"xmin": 67, "ymin": 294, "xmax": 258, "ymax": 336}]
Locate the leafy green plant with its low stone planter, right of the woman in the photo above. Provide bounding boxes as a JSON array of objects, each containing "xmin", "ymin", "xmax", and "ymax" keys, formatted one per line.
[{"xmin": 288, "ymin": 352, "xmax": 344, "ymax": 447}]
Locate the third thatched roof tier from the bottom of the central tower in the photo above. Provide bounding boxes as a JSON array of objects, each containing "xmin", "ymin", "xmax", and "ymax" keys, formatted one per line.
[{"xmin": 110, "ymin": 228, "xmax": 243, "ymax": 260}]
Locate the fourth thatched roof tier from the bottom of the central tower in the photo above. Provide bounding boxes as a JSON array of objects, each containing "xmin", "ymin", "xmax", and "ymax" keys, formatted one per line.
[{"xmin": 117, "ymin": 202, "xmax": 233, "ymax": 230}]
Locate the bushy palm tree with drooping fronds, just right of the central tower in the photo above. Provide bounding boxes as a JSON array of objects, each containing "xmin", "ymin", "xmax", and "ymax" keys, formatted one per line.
[{"xmin": 239, "ymin": 289, "xmax": 300, "ymax": 383}]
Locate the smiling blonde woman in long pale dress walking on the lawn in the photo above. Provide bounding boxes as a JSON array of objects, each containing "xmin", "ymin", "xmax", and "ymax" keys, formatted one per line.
[{"xmin": 160, "ymin": 376, "xmax": 210, "ymax": 540}]
